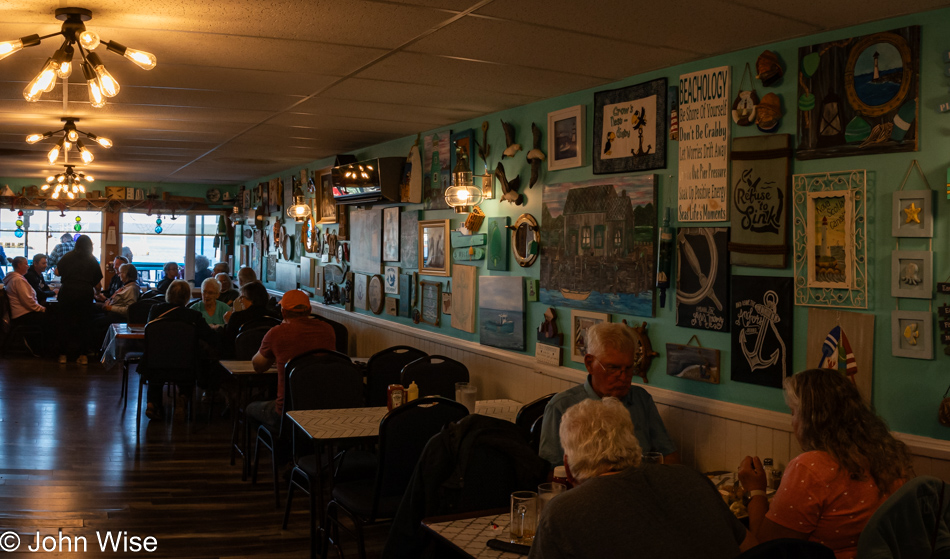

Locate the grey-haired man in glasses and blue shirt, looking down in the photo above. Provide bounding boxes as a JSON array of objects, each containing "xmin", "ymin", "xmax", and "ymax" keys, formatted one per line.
[{"xmin": 538, "ymin": 323, "xmax": 679, "ymax": 466}]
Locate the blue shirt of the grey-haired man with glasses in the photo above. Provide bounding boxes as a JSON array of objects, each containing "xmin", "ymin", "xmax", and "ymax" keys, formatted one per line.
[{"xmin": 538, "ymin": 375, "xmax": 676, "ymax": 466}]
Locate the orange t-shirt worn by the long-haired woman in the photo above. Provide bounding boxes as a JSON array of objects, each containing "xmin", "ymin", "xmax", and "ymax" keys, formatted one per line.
[{"xmin": 765, "ymin": 450, "xmax": 904, "ymax": 559}]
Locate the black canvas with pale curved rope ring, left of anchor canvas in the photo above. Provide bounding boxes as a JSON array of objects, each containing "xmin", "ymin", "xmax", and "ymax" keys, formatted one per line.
[{"xmin": 676, "ymin": 227, "xmax": 729, "ymax": 332}]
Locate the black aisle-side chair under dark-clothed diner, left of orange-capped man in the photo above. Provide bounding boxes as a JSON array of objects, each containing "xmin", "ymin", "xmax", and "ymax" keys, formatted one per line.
[{"xmin": 136, "ymin": 318, "xmax": 199, "ymax": 433}]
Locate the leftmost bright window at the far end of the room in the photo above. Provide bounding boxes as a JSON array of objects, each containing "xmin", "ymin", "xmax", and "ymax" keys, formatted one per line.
[{"xmin": 0, "ymin": 209, "xmax": 102, "ymax": 265}]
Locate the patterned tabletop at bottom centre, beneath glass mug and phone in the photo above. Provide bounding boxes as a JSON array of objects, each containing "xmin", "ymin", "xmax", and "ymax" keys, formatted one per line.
[{"xmin": 422, "ymin": 509, "xmax": 524, "ymax": 559}]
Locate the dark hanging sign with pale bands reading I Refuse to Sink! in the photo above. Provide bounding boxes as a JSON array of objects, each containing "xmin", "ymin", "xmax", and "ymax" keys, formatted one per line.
[{"xmin": 729, "ymin": 134, "xmax": 792, "ymax": 268}]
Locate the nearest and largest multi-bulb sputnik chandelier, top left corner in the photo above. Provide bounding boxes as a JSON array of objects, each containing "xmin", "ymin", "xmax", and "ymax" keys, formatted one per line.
[{"xmin": 0, "ymin": 8, "xmax": 156, "ymax": 107}]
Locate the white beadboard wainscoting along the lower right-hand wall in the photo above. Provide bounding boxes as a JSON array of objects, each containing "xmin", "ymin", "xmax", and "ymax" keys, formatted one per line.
[{"xmin": 312, "ymin": 303, "xmax": 950, "ymax": 481}]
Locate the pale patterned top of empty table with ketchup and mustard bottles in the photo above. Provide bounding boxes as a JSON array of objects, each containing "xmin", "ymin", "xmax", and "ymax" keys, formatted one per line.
[{"xmin": 290, "ymin": 400, "xmax": 521, "ymax": 440}]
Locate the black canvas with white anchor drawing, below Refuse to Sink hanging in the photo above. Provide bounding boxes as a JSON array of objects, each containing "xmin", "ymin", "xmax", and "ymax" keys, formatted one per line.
[{"xmin": 731, "ymin": 276, "xmax": 796, "ymax": 388}]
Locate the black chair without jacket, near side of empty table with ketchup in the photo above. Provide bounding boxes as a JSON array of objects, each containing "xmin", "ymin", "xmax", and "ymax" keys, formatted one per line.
[{"xmin": 323, "ymin": 397, "xmax": 468, "ymax": 559}]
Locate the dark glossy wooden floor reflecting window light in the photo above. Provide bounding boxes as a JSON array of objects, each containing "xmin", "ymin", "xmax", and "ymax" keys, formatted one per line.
[{"xmin": 0, "ymin": 356, "xmax": 387, "ymax": 558}]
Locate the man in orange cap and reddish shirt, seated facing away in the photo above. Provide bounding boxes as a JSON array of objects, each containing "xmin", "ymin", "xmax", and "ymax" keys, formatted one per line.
[{"xmin": 247, "ymin": 289, "xmax": 336, "ymax": 433}]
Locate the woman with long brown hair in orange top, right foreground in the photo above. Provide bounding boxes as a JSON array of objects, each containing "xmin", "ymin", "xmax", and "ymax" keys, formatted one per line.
[{"xmin": 739, "ymin": 369, "xmax": 913, "ymax": 559}]
